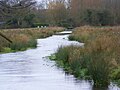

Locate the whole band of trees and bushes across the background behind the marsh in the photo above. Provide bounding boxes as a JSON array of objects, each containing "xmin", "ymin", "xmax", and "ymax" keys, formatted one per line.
[{"xmin": 0, "ymin": 0, "xmax": 120, "ymax": 28}]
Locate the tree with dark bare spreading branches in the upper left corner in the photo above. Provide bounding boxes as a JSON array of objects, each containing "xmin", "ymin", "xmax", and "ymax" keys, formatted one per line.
[{"xmin": 0, "ymin": 0, "xmax": 36, "ymax": 26}]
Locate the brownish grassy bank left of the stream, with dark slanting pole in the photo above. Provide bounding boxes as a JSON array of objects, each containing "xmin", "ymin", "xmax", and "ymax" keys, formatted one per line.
[{"xmin": 0, "ymin": 27, "xmax": 64, "ymax": 53}]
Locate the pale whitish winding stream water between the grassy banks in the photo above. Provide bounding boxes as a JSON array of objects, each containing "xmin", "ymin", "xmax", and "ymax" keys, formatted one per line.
[{"xmin": 0, "ymin": 32, "xmax": 120, "ymax": 90}]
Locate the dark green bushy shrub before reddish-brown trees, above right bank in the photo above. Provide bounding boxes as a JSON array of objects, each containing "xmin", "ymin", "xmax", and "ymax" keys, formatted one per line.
[{"xmin": 83, "ymin": 9, "xmax": 114, "ymax": 26}]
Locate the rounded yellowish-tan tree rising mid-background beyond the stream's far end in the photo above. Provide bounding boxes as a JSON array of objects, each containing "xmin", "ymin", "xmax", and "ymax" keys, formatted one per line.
[{"xmin": 48, "ymin": 0, "xmax": 67, "ymax": 24}]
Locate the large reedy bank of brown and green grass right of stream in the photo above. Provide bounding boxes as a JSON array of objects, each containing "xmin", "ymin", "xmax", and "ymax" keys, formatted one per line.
[{"xmin": 50, "ymin": 27, "xmax": 120, "ymax": 87}]
